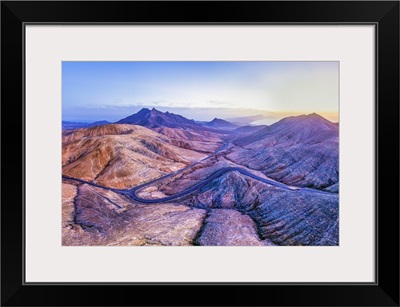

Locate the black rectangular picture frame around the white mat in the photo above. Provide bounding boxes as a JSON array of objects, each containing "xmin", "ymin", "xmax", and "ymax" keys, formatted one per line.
[{"xmin": 1, "ymin": 1, "xmax": 399, "ymax": 306}]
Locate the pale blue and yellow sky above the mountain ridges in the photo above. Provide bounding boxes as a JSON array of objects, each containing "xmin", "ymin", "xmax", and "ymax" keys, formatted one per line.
[{"xmin": 62, "ymin": 62, "xmax": 339, "ymax": 124}]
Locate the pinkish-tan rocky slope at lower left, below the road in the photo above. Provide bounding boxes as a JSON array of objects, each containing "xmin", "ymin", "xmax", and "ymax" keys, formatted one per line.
[{"xmin": 63, "ymin": 183, "xmax": 206, "ymax": 246}]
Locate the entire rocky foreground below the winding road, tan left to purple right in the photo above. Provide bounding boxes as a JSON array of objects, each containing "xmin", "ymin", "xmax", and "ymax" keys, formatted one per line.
[{"xmin": 63, "ymin": 173, "xmax": 339, "ymax": 246}]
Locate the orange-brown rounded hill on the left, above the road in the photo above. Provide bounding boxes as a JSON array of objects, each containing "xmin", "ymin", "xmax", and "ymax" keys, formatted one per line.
[{"xmin": 62, "ymin": 124, "xmax": 206, "ymax": 188}]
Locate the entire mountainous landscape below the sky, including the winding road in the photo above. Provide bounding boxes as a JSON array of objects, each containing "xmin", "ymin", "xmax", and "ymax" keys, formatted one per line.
[{"xmin": 62, "ymin": 109, "xmax": 339, "ymax": 246}]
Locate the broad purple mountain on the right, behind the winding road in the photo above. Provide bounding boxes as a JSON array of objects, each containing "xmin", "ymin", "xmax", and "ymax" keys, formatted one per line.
[{"xmin": 227, "ymin": 113, "xmax": 339, "ymax": 192}]
